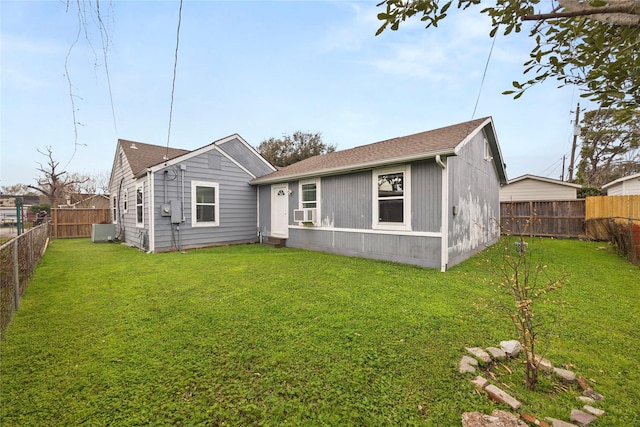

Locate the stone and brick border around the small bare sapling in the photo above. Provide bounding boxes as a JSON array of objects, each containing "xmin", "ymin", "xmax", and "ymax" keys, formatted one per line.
[{"xmin": 458, "ymin": 340, "xmax": 606, "ymax": 427}]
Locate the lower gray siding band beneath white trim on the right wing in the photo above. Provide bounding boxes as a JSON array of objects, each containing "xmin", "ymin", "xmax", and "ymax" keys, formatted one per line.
[{"xmin": 287, "ymin": 229, "xmax": 440, "ymax": 268}]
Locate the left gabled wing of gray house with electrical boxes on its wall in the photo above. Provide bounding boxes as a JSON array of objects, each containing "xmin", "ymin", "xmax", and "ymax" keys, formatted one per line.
[{"xmin": 109, "ymin": 134, "xmax": 276, "ymax": 252}]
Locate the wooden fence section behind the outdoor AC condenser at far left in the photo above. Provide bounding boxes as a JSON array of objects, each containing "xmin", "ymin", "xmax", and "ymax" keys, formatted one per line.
[{"xmin": 51, "ymin": 209, "xmax": 111, "ymax": 239}]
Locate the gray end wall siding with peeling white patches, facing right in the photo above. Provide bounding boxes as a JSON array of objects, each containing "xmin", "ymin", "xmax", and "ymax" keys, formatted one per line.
[{"xmin": 447, "ymin": 132, "xmax": 500, "ymax": 266}]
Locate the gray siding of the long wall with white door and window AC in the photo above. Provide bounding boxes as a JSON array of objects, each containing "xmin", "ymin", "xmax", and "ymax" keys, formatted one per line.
[{"xmin": 274, "ymin": 164, "xmax": 442, "ymax": 267}]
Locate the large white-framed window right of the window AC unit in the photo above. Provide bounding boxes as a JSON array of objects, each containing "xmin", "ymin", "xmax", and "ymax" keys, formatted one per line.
[{"xmin": 373, "ymin": 166, "xmax": 411, "ymax": 230}]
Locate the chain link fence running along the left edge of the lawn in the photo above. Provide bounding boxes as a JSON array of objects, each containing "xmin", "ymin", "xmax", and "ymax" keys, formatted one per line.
[{"xmin": 0, "ymin": 223, "xmax": 51, "ymax": 339}]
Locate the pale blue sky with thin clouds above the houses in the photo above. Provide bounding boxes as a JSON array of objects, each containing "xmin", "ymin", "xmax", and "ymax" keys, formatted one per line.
[{"xmin": 0, "ymin": 0, "xmax": 585, "ymax": 186}]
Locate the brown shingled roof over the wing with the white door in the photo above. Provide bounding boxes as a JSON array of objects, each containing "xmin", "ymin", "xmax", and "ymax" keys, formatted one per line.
[{"xmin": 251, "ymin": 117, "xmax": 506, "ymax": 184}]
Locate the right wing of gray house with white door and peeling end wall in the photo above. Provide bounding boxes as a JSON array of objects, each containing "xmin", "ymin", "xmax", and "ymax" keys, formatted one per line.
[{"xmin": 251, "ymin": 117, "xmax": 507, "ymax": 271}]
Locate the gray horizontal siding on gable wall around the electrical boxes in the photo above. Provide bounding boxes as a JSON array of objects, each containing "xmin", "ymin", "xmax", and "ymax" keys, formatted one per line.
[{"xmin": 153, "ymin": 151, "xmax": 257, "ymax": 252}]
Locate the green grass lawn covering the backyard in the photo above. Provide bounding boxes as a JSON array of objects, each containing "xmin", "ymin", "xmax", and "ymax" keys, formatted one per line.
[{"xmin": 0, "ymin": 239, "xmax": 640, "ymax": 427}]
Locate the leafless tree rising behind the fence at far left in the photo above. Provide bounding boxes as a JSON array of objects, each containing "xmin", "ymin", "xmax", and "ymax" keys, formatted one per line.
[{"xmin": 28, "ymin": 147, "xmax": 88, "ymax": 207}]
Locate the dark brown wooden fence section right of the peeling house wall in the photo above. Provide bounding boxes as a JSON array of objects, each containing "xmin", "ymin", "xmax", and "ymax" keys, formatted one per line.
[{"xmin": 500, "ymin": 199, "xmax": 585, "ymax": 238}]
